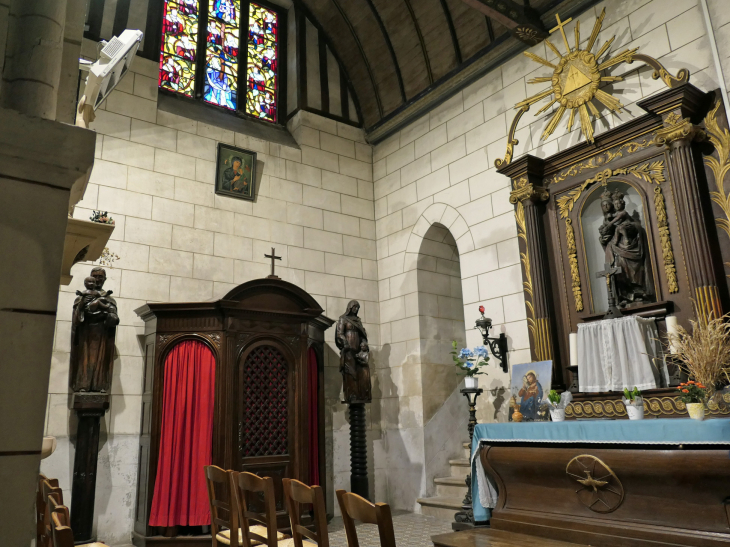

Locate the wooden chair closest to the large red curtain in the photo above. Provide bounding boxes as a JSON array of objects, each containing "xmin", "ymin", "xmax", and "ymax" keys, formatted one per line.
[{"xmin": 205, "ymin": 465, "xmax": 241, "ymax": 547}]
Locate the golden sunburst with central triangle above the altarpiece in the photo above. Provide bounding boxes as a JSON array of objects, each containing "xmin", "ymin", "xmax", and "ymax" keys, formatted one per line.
[{"xmin": 516, "ymin": 8, "xmax": 639, "ymax": 143}]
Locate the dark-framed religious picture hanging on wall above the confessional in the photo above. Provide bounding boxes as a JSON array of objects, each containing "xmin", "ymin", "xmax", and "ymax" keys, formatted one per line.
[{"xmin": 215, "ymin": 142, "xmax": 256, "ymax": 201}]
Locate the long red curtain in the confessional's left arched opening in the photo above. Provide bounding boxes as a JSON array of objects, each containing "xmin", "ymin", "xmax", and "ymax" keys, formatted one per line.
[{"xmin": 150, "ymin": 340, "xmax": 215, "ymax": 526}]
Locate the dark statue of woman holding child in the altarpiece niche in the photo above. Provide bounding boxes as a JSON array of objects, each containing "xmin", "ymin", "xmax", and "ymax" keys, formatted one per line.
[{"xmin": 598, "ymin": 189, "xmax": 654, "ymax": 308}]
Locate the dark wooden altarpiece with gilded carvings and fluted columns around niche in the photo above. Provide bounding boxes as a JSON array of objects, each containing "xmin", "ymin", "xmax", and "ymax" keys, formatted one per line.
[{"xmin": 498, "ymin": 83, "xmax": 730, "ymax": 418}]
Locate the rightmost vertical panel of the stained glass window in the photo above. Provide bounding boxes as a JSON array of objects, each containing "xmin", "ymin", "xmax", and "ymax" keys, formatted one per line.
[{"xmin": 246, "ymin": 3, "xmax": 279, "ymax": 122}]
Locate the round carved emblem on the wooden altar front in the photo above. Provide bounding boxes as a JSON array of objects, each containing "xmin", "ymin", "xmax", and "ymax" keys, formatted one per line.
[{"xmin": 565, "ymin": 454, "xmax": 624, "ymax": 514}]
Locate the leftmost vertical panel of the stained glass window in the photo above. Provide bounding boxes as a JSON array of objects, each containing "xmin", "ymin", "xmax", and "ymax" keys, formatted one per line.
[{"xmin": 158, "ymin": 0, "xmax": 198, "ymax": 97}]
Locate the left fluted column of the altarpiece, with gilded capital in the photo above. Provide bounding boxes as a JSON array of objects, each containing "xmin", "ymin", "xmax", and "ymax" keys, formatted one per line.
[{"xmin": 505, "ymin": 156, "xmax": 560, "ymax": 374}]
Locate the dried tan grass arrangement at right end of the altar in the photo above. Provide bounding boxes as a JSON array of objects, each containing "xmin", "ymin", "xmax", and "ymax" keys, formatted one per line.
[{"xmin": 665, "ymin": 313, "xmax": 730, "ymax": 395}]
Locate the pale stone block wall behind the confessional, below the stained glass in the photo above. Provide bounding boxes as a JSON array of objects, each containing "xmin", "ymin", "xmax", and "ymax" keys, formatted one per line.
[{"xmin": 42, "ymin": 54, "xmax": 372, "ymax": 544}]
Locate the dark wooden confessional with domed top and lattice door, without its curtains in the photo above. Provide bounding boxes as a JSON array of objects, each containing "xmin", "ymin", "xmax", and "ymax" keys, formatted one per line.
[{"xmin": 133, "ymin": 276, "xmax": 334, "ymax": 546}]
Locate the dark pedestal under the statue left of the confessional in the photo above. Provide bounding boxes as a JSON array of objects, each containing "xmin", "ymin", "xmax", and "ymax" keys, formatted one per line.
[{"xmin": 71, "ymin": 393, "xmax": 109, "ymax": 545}]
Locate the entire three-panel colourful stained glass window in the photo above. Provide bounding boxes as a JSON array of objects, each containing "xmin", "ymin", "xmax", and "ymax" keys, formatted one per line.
[{"xmin": 159, "ymin": 0, "xmax": 281, "ymax": 122}]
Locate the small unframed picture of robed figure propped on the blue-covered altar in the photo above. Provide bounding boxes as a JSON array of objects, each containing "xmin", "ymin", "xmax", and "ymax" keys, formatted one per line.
[{"xmin": 509, "ymin": 361, "xmax": 553, "ymax": 422}]
